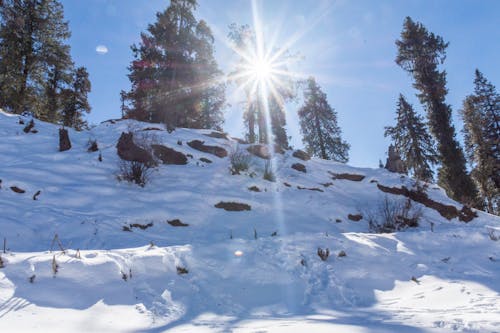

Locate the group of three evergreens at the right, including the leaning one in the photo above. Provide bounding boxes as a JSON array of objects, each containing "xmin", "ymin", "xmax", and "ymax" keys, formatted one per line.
[{"xmin": 385, "ymin": 17, "xmax": 500, "ymax": 214}]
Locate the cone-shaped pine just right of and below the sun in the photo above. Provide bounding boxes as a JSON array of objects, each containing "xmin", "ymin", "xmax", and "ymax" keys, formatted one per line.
[{"xmin": 298, "ymin": 78, "xmax": 349, "ymax": 162}]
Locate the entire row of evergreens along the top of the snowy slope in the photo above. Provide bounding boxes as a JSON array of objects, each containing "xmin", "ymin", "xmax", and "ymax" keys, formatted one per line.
[{"xmin": 0, "ymin": 0, "xmax": 500, "ymax": 214}]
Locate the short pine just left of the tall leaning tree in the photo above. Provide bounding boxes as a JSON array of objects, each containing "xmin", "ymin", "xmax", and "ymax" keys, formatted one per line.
[{"xmin": 385, "ymin": 94, "xmax": 437, "ymax": 182}]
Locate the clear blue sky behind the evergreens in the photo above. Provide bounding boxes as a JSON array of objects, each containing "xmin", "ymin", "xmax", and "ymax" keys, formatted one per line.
[{"xmin": 61, "ymin": 0, "xmax": 500, "ymax": 167}]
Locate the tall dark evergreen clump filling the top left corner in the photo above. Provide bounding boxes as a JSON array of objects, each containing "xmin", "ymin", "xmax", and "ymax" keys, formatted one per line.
[{"xmin": 0, "ymin": 0, "xmax": 72, "ymax": 122}]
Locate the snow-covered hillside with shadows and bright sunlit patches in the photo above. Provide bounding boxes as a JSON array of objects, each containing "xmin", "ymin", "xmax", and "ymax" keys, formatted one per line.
[{"xmin": 0, "ymin": 112, "xmax": 500, "ymax": 332}]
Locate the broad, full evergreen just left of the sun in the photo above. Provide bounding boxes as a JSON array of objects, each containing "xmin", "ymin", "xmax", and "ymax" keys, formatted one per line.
[{"xmin": 126, "ymin": 0, "xmax": 225, "ymax": 129}]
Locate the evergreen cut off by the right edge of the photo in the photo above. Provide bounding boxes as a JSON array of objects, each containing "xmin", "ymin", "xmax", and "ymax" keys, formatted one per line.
[{"xmin": 461, "ymin": 69, "xmax": 500, "ymax": 215}]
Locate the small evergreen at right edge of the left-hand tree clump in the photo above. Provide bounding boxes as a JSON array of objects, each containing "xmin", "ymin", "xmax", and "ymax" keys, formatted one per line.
[{"xmin": 61, "ymin": 67, "xmax": 91, "ymax": 130}]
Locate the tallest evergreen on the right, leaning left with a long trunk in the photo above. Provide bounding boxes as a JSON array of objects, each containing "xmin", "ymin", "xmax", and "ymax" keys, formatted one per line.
[{"xmin": 396, "ymin": 17, "xmax": 477, "ymax": 204}]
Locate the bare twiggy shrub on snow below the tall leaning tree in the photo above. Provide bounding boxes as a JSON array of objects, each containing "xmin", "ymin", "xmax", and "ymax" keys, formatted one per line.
[{"xmin": 366, "ymin": 196, "xmax": 422, "ymax": 233}]
